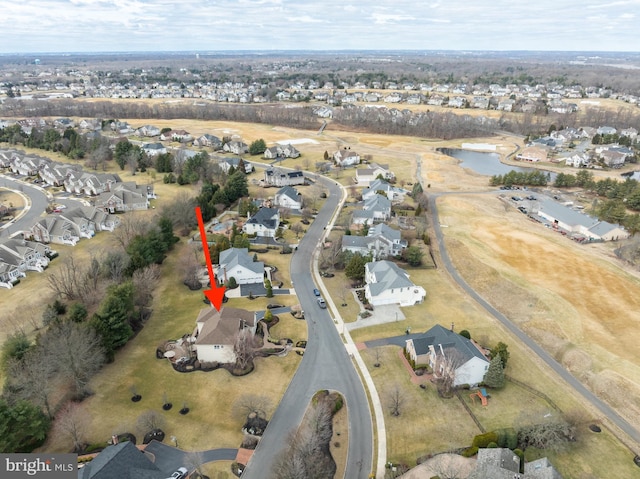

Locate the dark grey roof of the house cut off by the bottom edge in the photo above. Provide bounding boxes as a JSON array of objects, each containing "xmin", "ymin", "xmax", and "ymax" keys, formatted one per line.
[{"xmin": 78, "ymin": 441, "xmax": 167, "ymax": 479}]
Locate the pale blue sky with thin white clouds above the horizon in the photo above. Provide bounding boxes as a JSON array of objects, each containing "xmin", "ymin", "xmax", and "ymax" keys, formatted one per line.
[{"xmin": 0, "ymin": 0, "xmax": 640, "ymax": 53}]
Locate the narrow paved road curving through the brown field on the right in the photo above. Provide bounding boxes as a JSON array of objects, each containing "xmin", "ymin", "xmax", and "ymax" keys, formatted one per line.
[{"xmin": 429, "ymin": 194, "xmax": 640, "ymax": 442}]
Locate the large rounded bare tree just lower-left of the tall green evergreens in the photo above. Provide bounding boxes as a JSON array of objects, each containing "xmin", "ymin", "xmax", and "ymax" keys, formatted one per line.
[{"xmin": 40, "ymin": 322, "xmax": 105, "ymax": 397}]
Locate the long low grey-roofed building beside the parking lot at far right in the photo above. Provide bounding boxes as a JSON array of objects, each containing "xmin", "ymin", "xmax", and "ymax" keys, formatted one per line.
[{"xmin": 537, "ymin": 198, "xmax": 629, "ymax": 241}]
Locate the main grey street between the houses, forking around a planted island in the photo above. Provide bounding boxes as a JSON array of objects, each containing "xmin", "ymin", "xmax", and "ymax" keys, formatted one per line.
[{"xmin": 242, "ymin": 179, "xmax": 373, "ymax": 479}]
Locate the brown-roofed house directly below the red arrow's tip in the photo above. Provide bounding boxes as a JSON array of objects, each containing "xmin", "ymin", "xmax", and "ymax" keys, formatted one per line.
[{"xmin": 193, "ymin": 307, "xmax": 257, "ymax": 363}]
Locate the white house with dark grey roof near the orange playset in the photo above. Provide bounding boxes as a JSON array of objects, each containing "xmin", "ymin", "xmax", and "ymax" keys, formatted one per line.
[{"xmin": 406, "ymin": 324, "xmax": 489, "ymax": 386}]
